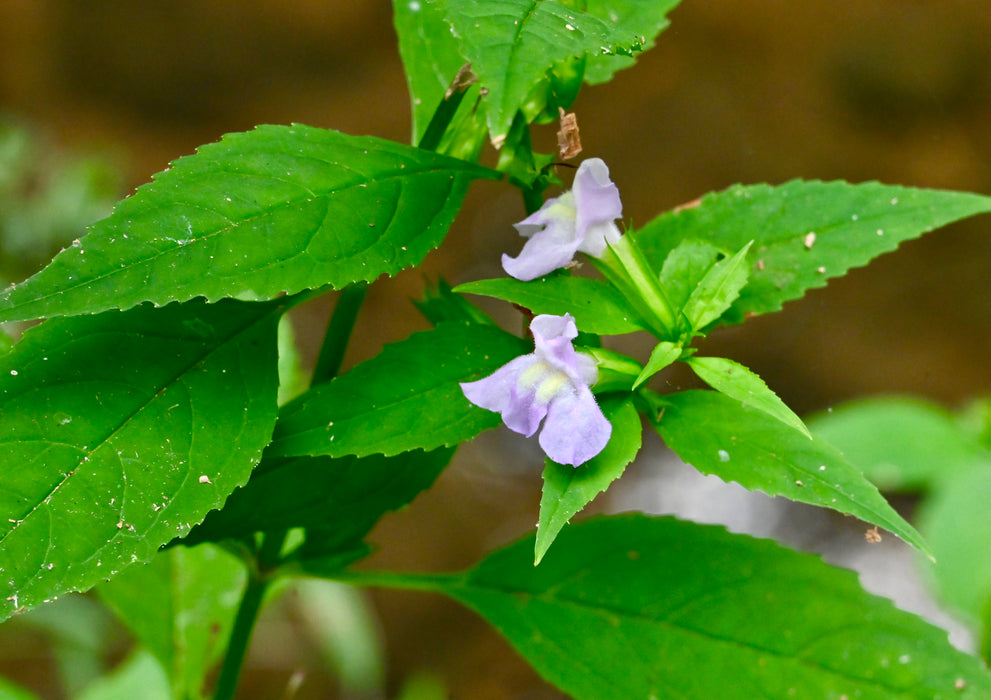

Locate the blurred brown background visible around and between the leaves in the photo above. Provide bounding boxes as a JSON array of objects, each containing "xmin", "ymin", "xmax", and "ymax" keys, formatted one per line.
[{"xmin": 0, "ymin": 0, "xmax": 991, "ymax": 698}]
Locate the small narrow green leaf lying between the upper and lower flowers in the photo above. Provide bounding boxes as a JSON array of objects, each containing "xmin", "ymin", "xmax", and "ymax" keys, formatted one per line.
[{"xmin": 455, "ymin": 274, "xmax": 645, "ymax": 335}]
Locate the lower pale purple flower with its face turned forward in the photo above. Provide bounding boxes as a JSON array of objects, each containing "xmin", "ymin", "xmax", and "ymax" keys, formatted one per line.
[{"xmin": 461, "ymin": 314, "xmax": 612, "ymax": 467}]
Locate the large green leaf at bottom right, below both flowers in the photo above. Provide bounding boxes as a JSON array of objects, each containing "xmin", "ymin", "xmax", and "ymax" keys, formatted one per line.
[{"xmin": 432, "ymin": 515, "xmax": 991, "ymax": 700}]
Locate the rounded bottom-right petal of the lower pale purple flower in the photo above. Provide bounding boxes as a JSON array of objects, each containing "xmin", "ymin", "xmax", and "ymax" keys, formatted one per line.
[{"xmin": 539, "ymin": 386, "xmax": 612, "ymax": 467}]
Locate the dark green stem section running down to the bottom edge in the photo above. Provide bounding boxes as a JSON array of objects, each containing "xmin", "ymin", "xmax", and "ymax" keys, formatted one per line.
[{"xmin": 213, "ymin": 531, "xmax": 287, "ymax": 700}]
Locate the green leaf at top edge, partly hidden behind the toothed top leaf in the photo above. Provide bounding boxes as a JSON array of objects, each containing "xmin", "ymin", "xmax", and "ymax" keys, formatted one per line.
[{"xmin": 583, "ymin": 0, "xmax": 679, "ymax": 85}]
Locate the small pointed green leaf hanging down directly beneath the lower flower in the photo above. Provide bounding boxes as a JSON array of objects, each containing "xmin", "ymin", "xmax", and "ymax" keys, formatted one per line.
[{"xmin": 534, "ymin": 399, "xmax": 641, "ymax": 565}]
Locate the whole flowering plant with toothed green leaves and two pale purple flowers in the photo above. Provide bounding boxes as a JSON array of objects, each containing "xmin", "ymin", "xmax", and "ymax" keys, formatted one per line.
[{"xmin": 0, "ymin": 0, "xmax": 991, "ymax": 700}]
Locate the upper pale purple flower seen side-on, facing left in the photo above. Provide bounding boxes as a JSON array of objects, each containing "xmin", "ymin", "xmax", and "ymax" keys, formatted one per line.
[{"xmin": 502, "ymin": 158, "xmax": 623, "ymax": 282}]
